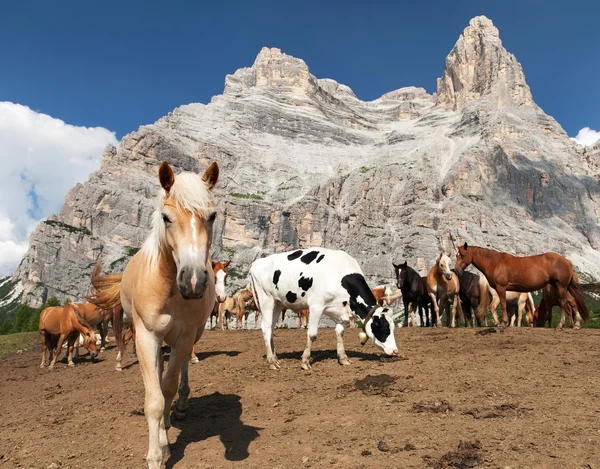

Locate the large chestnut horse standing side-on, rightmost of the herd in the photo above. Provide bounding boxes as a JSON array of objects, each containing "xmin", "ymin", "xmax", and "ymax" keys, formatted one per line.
[{"xmin": 455, "ymin": 243, "xmax": 589, "ymax": 328}]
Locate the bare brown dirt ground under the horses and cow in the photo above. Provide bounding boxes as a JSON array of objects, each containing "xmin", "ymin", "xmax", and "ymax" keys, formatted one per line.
[{"xmin": 0, "ymin": 328, "xmax": 600, "ymax": 469}]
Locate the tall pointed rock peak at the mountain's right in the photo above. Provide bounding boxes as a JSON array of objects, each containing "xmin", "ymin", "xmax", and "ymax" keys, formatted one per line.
[{"xmin": 437, "ymin": 16, "xmax": 534, "ymax": 111}]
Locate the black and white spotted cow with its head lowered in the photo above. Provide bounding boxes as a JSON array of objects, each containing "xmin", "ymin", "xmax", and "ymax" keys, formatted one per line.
[{"xmin": 250, "ymin": 248, "xmax": 398, "ymax": 370}]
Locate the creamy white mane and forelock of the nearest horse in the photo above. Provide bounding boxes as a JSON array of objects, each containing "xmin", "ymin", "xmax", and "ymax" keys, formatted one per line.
[{"xmin": 141, "ymin": 173, "xmax": 216, "ymax": 269}]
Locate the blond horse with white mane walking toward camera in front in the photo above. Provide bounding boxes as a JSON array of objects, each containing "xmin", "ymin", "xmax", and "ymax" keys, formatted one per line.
[{"xmin": 92, "ymin": 161, "xmax": 219, "ymax": 469}]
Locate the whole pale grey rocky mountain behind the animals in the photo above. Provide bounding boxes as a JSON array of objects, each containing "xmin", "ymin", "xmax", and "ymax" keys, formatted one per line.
[{"xmin": 13, "ymin": 17, "xmax": 600, "ymax": 304}]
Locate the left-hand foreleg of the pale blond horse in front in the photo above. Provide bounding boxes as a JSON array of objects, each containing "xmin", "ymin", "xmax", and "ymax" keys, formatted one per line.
[{"xmin": 135, "ymin": 322, "xmax": 165, "ymax": 469}]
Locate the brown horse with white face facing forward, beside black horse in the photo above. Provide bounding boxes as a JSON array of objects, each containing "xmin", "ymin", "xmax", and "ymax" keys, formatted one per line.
[{"xmin": 427, "ymin": 253, "xmax": 465, "ymax": 327}]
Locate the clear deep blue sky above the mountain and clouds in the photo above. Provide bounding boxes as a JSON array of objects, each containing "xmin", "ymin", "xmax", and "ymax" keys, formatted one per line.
[{"xmin": 0, "ymin": 0, "xmax": 600, "ymax": 138}]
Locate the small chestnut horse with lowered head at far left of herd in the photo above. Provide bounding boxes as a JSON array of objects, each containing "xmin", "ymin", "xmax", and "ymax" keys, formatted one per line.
[{"xmin": 38, "ymin": 303, "xmax": 97, "ymax": 368}]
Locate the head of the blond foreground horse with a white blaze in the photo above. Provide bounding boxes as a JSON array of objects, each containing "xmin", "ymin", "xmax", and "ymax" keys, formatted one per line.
[{"xmin": 157, "ymin": 161, "xmax": 219, "ymax": 299}]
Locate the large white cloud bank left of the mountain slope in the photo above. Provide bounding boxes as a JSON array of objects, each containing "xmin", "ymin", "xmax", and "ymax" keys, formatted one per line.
[{"xmin": 0, "ymin": 102, "xmax": 117, "ymax": 276}]
